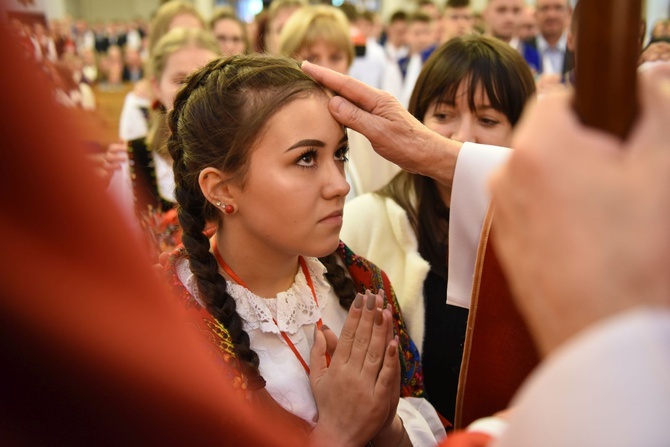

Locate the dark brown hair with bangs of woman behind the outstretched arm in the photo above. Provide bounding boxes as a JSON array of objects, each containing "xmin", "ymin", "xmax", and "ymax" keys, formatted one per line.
[{"xmin": 377, "ymin": 35, "xmax": 535, "ymax": 278}]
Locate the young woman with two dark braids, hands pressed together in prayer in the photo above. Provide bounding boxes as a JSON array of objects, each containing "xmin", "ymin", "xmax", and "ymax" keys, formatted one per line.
[{"xmin": 166, "ymin": 55, "xmax": 444, "ymax": 445}]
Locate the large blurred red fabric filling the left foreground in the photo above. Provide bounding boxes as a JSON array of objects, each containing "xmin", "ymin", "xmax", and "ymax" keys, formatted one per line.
[{"xmin": 0, "ymin": 21, "xmax": 304, "ymax": 446}]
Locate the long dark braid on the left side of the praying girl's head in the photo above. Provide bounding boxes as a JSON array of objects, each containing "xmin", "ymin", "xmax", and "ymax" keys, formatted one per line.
[{"xmin": 168, "ymin": 58, "xmax": 265, "ymax": 389}]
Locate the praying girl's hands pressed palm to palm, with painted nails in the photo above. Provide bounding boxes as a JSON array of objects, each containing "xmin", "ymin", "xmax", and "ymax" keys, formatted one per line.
[{"xmin": 310, "ymin": 291, "xmax": 404, "ymax": 447}]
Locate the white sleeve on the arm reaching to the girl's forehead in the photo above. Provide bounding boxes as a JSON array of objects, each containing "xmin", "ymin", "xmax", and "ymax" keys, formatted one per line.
[{"xmin": 447, "ymin": 143, "xmax": 511, "ymax": 309}]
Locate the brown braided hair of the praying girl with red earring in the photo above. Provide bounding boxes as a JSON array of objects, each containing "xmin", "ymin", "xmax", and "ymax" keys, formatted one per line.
[{"xmin": 168, "ymin": 55, "xmax": 355, "ymax": 389}]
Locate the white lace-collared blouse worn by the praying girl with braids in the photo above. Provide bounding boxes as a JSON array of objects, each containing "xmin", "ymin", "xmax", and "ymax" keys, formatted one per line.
[{"xmin": 177, "ymin": 258, "xmax": 444, "ymax": 445}]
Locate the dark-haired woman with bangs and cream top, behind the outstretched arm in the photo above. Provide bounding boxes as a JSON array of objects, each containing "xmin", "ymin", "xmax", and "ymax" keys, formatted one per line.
[{"xmin": 342, "ymin": 36, "xmax": 535, "ymax": 421}]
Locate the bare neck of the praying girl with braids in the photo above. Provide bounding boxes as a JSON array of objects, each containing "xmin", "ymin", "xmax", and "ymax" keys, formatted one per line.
[{"xmin": 213, "ymin": 228, "xmax": 300, "ymax": 298}]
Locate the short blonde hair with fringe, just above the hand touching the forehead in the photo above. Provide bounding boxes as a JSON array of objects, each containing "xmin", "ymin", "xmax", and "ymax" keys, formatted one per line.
[{"xmin": 279, "ymin": 5, "xmax": 354, "ymax": 66}]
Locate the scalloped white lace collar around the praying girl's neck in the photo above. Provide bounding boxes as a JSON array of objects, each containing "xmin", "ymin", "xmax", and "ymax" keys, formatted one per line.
[{"xmin": 176, "ymin": 258, "xmax": 330, "ymax": 334}]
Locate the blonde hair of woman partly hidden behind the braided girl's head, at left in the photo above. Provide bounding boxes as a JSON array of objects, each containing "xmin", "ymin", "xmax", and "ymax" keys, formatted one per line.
[{"xmin": 146, "ymin": 28, "xmax": 221, "ymax": 157}]
